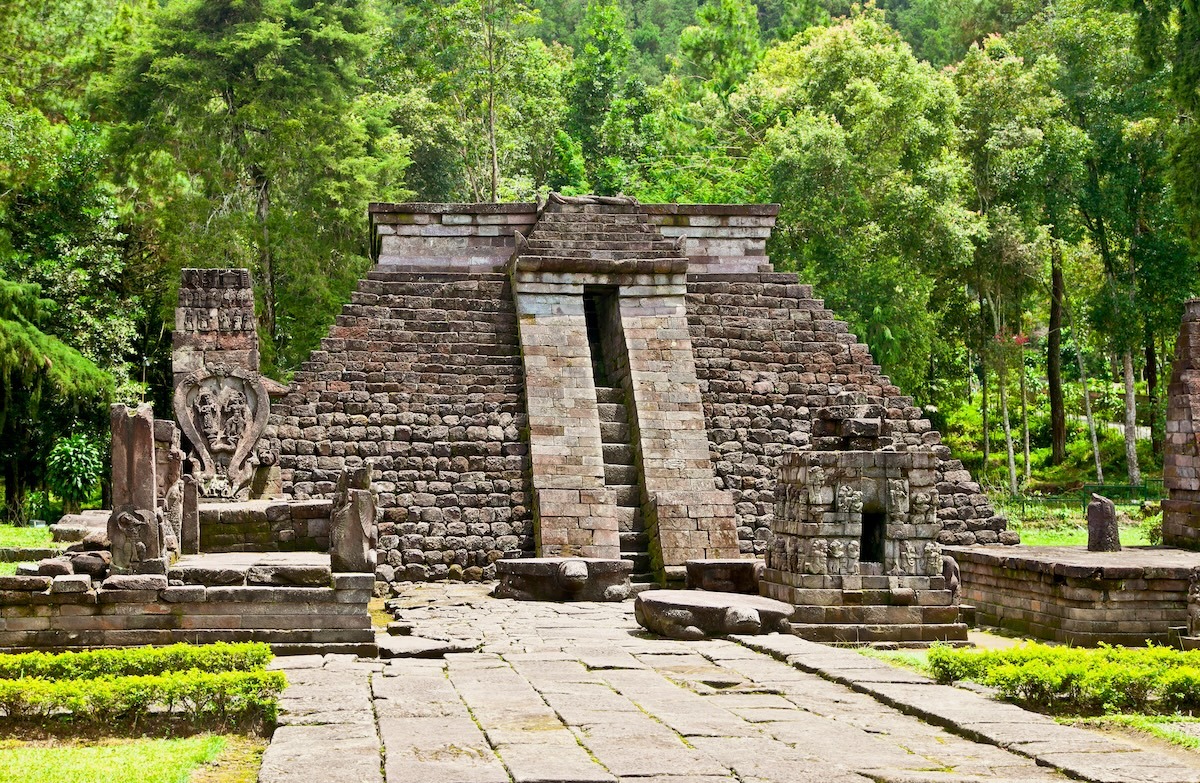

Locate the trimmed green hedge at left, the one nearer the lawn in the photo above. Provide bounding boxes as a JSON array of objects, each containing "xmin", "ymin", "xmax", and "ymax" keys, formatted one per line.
[{"xmin": 0, "ymin": 669, "xmax": 287, "ymax": 724}]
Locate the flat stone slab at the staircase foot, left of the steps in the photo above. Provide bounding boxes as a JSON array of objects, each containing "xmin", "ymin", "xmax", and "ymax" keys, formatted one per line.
[{"xmin": 494, "ymin": 557, "xmax": 634, "ymax": 600}]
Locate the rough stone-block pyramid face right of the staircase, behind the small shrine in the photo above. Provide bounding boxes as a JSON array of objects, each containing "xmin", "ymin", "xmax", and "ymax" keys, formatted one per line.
[{"xmin": 688, "ymin": 273, "xmax": 1003, "ymax": 555}]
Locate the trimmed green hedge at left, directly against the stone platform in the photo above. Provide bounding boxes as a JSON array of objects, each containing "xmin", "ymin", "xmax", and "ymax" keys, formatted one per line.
[{"xmin": 0, "ymin": 641, "xmax": 274, "ymax": 680}]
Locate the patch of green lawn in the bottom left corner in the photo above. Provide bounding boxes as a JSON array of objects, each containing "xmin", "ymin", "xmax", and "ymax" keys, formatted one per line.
[{"xmin": 0, "ymin": 734, "xmax": 226, "ymax": 783}]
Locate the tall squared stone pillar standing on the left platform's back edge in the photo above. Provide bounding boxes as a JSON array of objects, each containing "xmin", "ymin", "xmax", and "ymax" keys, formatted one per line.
[{"xmin": 108, "ymin": 405, "xmax": 167, "ymax": 574}]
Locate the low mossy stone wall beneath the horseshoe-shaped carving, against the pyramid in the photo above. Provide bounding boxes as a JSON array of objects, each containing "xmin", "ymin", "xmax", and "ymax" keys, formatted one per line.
[{"xmin": 199, "ymin": 498, "xmax": 332, "ymax": 552}]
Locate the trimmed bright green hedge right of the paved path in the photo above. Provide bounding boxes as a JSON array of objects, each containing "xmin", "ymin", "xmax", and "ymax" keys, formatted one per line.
[{"xmin": 928, "ymin": 642, "xmax": 1200, "ymax": 715}]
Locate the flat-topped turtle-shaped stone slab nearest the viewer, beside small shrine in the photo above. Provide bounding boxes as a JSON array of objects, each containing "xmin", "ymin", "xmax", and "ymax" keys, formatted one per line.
[{"xmin": 634, "ymin": 590, "xmax": 792, "ymax": 639}]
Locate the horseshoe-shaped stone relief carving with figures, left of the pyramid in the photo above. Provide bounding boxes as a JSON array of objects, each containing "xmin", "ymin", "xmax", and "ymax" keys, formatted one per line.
[{"xmin": 174, "ymin": 365, "xmax": 270, "ymax": 498}]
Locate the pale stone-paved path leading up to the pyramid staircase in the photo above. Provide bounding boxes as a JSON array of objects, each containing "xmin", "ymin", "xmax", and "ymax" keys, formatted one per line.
[{"xmin": 259, "ymin": 585, "xmax": 1200, "ymax": 783}]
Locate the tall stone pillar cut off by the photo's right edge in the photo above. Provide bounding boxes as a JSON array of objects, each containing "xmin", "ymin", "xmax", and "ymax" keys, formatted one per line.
[{"xmin": 1163, "ymin": 299, "xmax": 1200, "ymax": 549}]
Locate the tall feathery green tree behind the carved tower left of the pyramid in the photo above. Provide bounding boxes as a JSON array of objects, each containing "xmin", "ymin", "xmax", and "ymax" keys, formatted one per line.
[{"xmin": 97, "ymin": 0, "xmax": 407, "ymax": 366}]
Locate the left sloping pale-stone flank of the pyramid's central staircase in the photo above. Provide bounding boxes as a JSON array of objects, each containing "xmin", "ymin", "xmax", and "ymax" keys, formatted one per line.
[{"xmin": 514, "ymin": 278, "xmax": 620, "ymax": 557}]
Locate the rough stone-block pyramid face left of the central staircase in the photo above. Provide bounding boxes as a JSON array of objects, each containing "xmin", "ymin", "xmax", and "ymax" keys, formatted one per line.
[{"xmin": 276, "ymin": 265, "xmax": 534, "ymax": 581}]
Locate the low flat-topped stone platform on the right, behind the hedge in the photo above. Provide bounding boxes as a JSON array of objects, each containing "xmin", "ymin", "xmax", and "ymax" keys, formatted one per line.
[{"xmin": 944, "ymin": 546, "xmax": 1194, "ymax": 646}]
